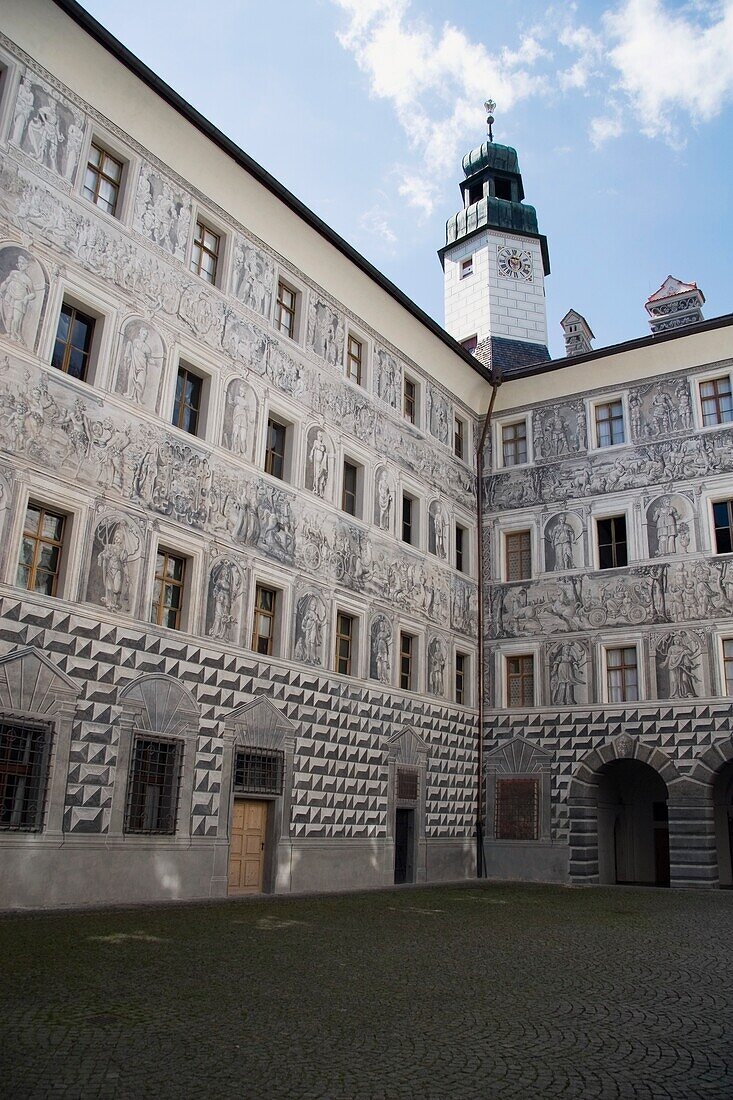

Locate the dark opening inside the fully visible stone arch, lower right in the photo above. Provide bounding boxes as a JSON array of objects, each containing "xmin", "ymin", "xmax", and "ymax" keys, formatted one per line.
[{"xmin": 598, "ymin": 759, "xmax": 669, "ymax": 887}]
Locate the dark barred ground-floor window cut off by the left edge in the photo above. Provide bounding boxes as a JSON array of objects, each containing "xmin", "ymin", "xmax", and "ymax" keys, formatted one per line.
[{"xmin": 0, "ymin": 719, "xmax": 51, "ymax": 832}]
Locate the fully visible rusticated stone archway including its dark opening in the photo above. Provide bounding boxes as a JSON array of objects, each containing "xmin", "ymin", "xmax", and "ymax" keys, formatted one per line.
[{"xmin": 568, "ymin": 733, "xmax": 680, "ymax": 886}]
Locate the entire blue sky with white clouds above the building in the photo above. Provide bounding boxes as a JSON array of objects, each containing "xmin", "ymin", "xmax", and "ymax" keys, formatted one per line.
[{"xmin": 79, "ymin": 0, "xmax": 733, "ymax": 356}]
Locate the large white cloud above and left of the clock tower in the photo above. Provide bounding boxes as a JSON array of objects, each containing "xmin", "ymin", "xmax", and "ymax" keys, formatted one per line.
[{"xmin": 333, "ymin": 0, "xmax": 548, "ymax": 215}]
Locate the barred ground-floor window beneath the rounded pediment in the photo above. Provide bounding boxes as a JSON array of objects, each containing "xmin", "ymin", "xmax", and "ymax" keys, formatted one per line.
[{"xmin": 124, "ymin": 737, "xmax": 182, "ymax": 836}]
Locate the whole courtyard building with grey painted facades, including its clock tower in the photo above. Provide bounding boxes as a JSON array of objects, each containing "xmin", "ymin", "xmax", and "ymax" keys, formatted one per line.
[{"xmin": 0, "ymin": 0, "xmax": 733, "ymax": 908}]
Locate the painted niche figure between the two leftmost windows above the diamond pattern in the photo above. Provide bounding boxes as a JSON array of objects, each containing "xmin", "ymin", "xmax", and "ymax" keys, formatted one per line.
[{"xmin": 87, "ymin": 513, "xmax": 143, "ymax": 612}]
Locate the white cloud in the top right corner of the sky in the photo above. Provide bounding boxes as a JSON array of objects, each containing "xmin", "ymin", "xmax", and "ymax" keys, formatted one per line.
[{"xmin": 603, "ymin": 0, "xmax": 733, "ymax": 139}]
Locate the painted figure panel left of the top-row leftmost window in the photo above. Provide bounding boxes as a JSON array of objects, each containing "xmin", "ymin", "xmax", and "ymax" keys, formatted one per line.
[{"xmin": 10, "ymin": 74, "xmax": 85, "ymax": 180}]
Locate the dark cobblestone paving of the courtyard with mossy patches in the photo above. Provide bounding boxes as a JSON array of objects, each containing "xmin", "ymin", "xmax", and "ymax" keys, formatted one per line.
[{"xmin": 0, "ymin": 883, "xmax": 733, "ymax": 1100}]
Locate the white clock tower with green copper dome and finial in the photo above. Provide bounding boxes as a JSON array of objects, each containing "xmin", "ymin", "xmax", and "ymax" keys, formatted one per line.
[{"xmin": 438, "ymin": 102, "xmax": 549, "ymax": 374}]
